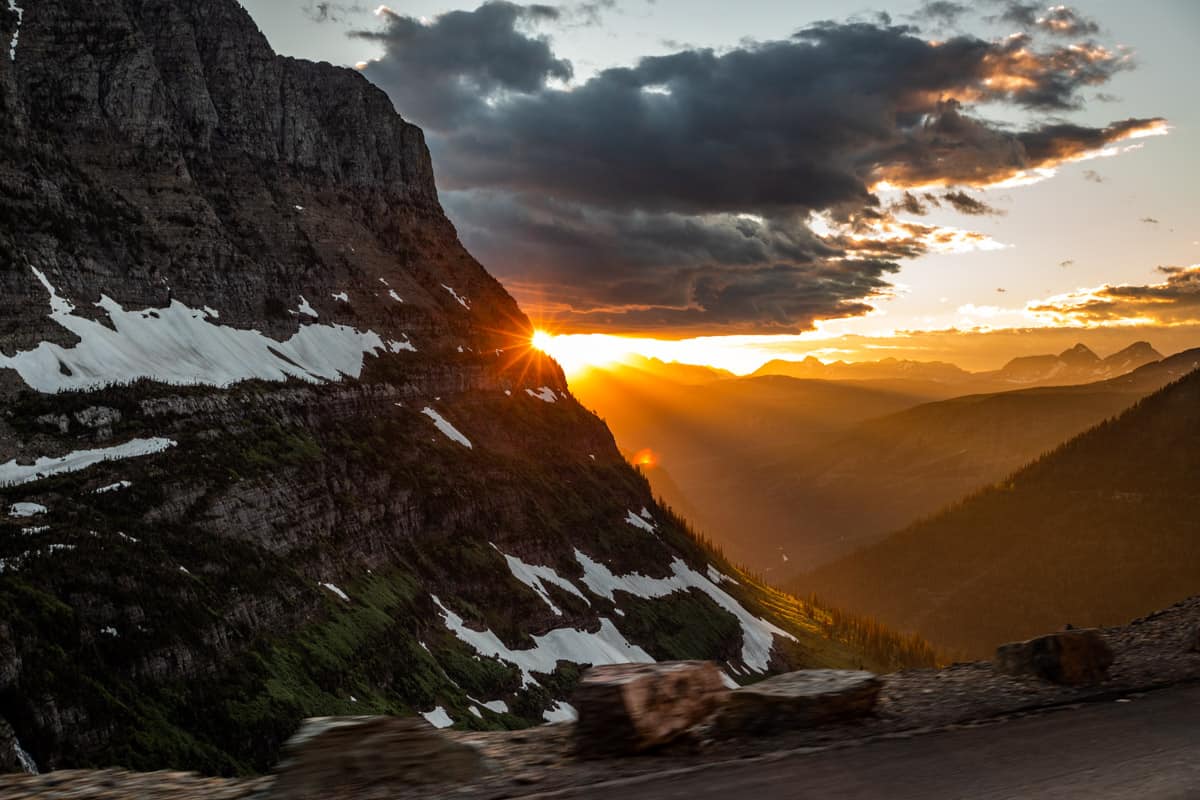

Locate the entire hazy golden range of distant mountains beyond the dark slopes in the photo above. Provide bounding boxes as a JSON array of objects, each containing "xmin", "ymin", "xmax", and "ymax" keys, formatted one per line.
[{"xmin": 571, "ymin": 343, "xmax": 1200, "ymax": 575}]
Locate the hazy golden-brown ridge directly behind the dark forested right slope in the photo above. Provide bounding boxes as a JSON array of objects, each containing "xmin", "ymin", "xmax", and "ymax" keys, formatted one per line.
[{"xmin": 754, "ymin": 350, "xmax": 1200, "ymax": 560}]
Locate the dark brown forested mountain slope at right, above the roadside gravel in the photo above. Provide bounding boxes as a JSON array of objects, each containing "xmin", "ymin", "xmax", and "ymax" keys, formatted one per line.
[{"xmin": 803, "ymin": 372, "xmax": 1200, "ymax": 656}]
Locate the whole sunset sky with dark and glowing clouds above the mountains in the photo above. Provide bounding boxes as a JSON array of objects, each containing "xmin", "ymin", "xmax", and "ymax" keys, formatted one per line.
[{"xmin": 238, "ymin": 0, "xmax": 1200, "ymax": 372}]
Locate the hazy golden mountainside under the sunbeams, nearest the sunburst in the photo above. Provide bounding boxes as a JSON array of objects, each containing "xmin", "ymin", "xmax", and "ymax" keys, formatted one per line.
[{"xmin": 571, "ymin": 365, "xmax": 940, "ymax": 571}]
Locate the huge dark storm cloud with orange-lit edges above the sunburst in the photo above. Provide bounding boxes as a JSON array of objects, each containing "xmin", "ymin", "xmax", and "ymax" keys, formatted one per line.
[{"xmin": 364, "ymin": 2, "xmax": 1157, "ymax": 331}]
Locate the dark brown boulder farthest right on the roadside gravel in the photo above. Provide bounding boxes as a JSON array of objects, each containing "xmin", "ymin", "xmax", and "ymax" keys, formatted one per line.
[{"xmin": 995, "ymin": 628, "xmax": 1112, "ymax": 686}]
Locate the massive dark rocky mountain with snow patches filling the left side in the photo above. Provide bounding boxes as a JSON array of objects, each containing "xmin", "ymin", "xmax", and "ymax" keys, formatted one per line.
[{"xmin": 0, "ymin": 0, "xmax": 932, "ymax": 774}]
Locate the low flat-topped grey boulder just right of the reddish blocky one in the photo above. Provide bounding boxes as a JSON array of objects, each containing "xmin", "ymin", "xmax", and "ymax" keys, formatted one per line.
[{"xmin": 715, "ymin": 669, "xmax": 883, "ymax": 736}]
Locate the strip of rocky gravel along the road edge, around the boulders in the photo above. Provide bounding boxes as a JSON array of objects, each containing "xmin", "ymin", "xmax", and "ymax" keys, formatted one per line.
[{"xmin": 0, "ymin": 596, "xmax": 1200, "ymax": 800}]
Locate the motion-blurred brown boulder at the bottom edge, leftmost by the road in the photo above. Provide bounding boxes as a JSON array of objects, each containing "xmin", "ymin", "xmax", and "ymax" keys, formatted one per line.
[{"xmin": 268, "ymin": 716, "xmax": 484, "ymax": 800}]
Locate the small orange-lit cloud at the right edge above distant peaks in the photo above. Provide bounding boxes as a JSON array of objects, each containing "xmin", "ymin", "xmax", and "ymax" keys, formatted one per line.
[{"xmin": 1027, "ymin": 264, "xmax": 1200, "ymax": 326}]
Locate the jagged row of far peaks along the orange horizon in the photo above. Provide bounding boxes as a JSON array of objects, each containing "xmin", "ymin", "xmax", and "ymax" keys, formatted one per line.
[{"xmin": 755, "ymin": 342, "xmax": 1163, "ymax": 397}]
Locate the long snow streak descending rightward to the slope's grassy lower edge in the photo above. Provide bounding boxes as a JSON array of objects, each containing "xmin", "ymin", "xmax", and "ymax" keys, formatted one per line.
[{"xmin": 575, "ymin": 549, "xmax": 796, "ymax": 673}]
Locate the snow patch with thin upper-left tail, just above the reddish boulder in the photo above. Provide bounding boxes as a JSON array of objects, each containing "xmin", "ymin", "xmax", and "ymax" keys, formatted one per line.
[{"xmin": 432, "ymin": 596, "xmax": 654, "ymax": 686}]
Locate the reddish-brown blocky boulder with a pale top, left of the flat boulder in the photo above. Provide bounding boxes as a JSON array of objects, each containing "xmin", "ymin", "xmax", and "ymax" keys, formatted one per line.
[{"xmin": 571, "ymin": 661, "xmax": 730, "ymax": 757}]
